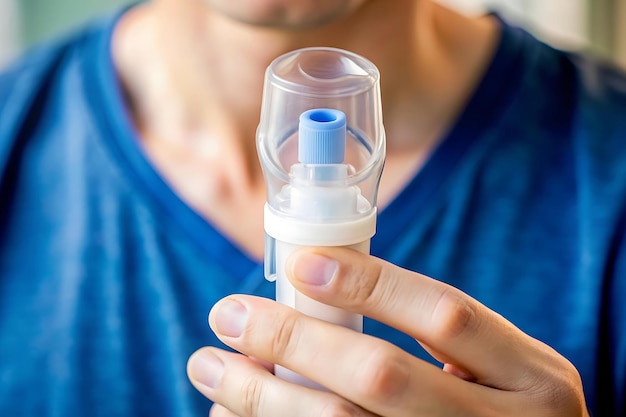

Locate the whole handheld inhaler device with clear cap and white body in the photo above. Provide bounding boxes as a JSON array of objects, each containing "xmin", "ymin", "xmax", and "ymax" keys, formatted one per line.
[{"xmin": 257, "ymin": 48, "xmax": 385, "ymax": 388}]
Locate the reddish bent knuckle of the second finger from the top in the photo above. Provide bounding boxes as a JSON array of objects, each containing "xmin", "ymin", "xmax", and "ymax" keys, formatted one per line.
[{"xmin": 357, "ymin": 346, "xmax": 411, "ymax": 404}]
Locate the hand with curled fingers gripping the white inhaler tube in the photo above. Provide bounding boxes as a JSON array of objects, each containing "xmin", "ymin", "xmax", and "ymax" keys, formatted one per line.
[{"xmin": 188, "ymin": 248, "xmax": 588, "ymax": 417}]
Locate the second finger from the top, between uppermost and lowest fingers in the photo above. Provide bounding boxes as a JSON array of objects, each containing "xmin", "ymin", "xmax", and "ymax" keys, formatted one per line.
[{"xmin": 209, "ymin": 296, "xmax": 495, "ymax": 417}]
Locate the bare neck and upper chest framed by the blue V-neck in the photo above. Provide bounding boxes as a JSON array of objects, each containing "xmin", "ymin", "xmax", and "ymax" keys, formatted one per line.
[{"xmin": 108, "ymin": 0, "xmax": 497, "ymax": 254}]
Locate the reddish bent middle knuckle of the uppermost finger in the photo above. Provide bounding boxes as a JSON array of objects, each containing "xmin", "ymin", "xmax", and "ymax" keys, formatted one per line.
[{"xmin": 431, "ymin": 289, "xmax": 478, "ymax": 341}]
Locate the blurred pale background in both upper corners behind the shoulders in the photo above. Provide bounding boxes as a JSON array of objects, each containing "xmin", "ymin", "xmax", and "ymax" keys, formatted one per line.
[{"xmin": 0, "ymin": 0, "xmax": 626, "ymax": 67}]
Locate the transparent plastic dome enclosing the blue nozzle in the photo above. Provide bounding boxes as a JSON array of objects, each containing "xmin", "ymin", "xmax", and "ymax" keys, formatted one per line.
[{"xmin": 257, "ymin": 48, "xmax": 385, "ymax": 221}]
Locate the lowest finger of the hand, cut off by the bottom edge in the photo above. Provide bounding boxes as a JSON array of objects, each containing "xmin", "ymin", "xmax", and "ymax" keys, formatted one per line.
[{"xmin": 187, "ymin": 348, "xmax": 373, "ymax": 417}]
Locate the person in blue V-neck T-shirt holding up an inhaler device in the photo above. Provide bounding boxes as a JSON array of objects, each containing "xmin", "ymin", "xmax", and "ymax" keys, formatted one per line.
[{"xmin": 0, "ymin": 0, "xmax": 626, "ymax": 417}]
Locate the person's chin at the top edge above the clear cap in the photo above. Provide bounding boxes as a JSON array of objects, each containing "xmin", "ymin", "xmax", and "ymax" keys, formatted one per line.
[{"xmin": 204, "ymin": 0, "xmax": 366, "ymax": 30}]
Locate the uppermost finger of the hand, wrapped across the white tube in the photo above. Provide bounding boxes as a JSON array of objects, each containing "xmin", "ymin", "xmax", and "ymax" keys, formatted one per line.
[{"xmin": 286, "ymin": 248, "xmax": 551, "ymax": 390}]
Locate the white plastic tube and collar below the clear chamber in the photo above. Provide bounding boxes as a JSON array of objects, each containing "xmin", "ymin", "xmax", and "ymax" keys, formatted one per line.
[{"xmin": 265, "ymin": 205, "xmax": 376, "ymax": 389}]
